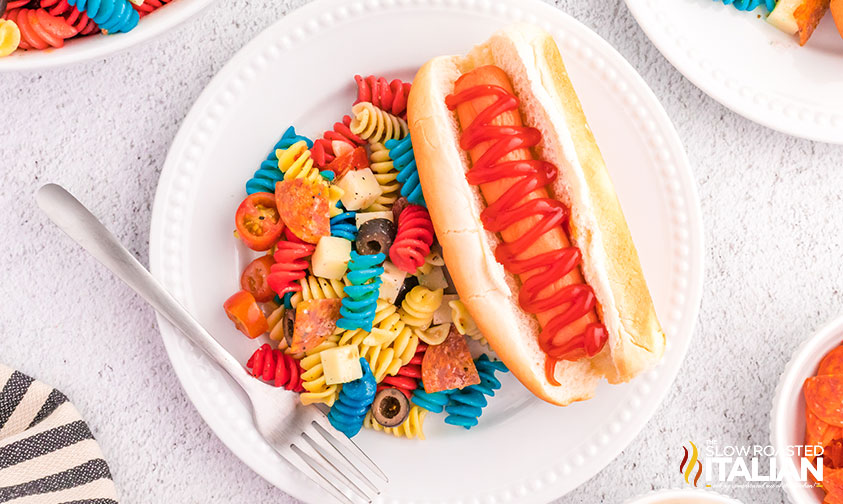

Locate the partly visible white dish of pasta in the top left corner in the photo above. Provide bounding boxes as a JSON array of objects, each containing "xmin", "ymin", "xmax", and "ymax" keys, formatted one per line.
[{"xmin": 0, "ymin": 0, "xmax": 214, "ymax": 72}]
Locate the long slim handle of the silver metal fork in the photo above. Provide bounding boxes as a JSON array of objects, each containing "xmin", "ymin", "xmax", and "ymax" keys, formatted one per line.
[{"xmin": 35, "ymin": 184, "xmax": 247, "ymax": 389}]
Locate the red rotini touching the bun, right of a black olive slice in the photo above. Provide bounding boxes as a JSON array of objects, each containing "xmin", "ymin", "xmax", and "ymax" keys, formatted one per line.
[{"xmin": 389, "ymin": 205, "xmax": 433, "ymax": 273}]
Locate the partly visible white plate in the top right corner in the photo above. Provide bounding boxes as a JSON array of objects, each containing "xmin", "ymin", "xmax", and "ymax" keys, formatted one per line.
[{"xmin": 626, "ymin": 0, "xmax": 843, "ymax": 143}]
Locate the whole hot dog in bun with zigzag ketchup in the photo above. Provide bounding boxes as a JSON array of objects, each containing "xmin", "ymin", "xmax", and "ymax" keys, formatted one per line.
[{"xmin": 407, "ymin": 25, "xmax": 665, "ymax": 405}]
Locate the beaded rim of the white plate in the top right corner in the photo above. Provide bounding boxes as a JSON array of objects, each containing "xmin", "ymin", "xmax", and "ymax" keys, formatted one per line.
[{"xmin": 624, "ymin": 0, "xmax": 843, "ymax": 145}]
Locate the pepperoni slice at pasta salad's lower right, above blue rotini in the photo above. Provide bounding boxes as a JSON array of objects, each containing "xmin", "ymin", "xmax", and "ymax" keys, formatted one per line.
[{"xmin": 422, "ymin": 324, "xmax": 480, "ymax": 393}]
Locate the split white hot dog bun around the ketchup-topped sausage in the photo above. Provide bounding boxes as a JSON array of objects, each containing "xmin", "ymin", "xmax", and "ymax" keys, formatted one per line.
[{"xmin": 408, "ymin": 25, "xmax": 665, "ymax": 405}]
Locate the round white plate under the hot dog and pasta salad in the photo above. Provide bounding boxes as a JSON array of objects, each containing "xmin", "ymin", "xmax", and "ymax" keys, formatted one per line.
[{"xmin": 150, "ymin": 0, "xmax": 703, "ymax": 503}]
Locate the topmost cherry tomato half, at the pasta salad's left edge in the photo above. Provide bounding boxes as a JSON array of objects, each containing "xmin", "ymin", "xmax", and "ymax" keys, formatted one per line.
[{"xmin": 235, "ymin": 192, "xmax": 284, "ymax": 252}]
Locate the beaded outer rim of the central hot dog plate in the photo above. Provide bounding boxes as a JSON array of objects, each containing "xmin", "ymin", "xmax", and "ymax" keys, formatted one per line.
[{"xmin": 150, "ymin": 0, "xmax": 704, "ymax": 502}]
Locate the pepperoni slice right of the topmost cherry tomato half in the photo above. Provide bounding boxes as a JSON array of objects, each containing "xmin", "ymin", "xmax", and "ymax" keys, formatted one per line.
[{"xmin": 275, "ymin": 179, "xmax": 331, "ymax": 243}]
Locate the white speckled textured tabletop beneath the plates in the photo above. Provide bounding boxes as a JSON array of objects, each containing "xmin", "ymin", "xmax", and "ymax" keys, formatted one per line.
[{"xmin": 0, "ymin": 0, "xmax": 843, "ymax": 503}]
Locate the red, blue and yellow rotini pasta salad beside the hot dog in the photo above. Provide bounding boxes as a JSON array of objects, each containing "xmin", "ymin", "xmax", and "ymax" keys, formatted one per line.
[{"xmin": 224, "ymin": 76, "xmax": 507, "ymax": 439}]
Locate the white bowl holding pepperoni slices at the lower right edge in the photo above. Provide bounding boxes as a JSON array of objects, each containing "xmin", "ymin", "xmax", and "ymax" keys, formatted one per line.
[{"xmin": 770, "ymin": 317, "xmax": 843, "ymax": 504}]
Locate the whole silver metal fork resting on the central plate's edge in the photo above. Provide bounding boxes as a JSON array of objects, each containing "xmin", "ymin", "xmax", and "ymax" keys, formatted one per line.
[{"xmin": 35, "ymin": 184, "xmax": 388, "ymax": 504}]
